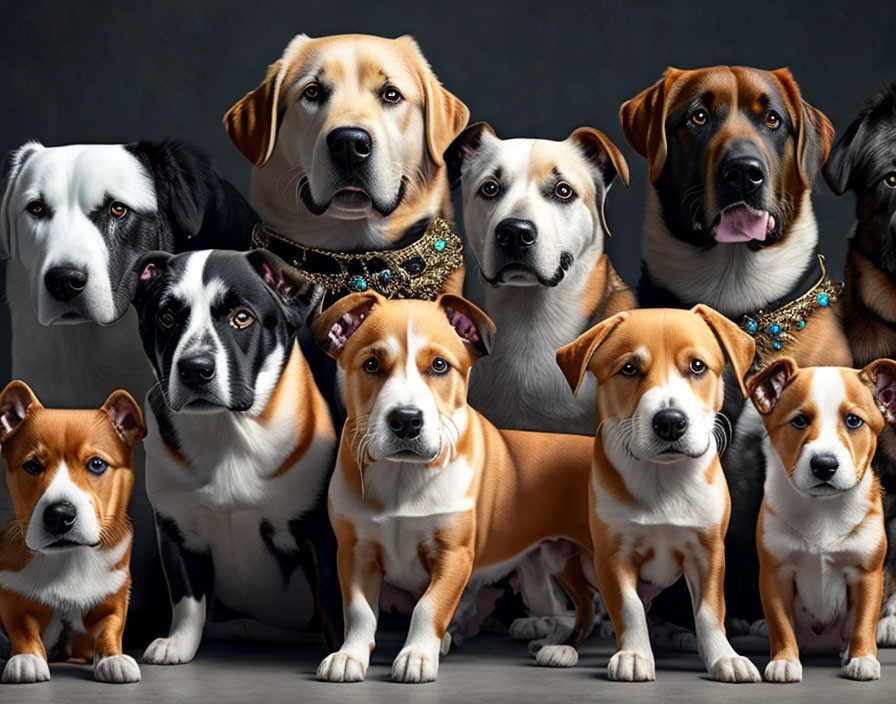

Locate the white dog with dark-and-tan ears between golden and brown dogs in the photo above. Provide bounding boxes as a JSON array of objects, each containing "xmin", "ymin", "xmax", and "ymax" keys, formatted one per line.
[{"xmin": 446, "ymin": 122, "xmax": 635, "ymax": 435}]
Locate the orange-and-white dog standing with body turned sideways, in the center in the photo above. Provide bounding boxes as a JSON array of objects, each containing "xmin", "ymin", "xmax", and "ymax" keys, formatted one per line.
[{"xmin": 312, "ymin": 293, "xmax": 592, "ymax": 682}]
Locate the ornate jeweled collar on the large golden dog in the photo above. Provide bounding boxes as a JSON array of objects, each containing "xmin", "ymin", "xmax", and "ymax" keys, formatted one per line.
[{"xmin": 252, "ymin": 217, "xmax": 464, "ymax": 301}]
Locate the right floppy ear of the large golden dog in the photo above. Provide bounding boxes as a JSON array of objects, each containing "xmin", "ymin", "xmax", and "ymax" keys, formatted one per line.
[{"xmin": 395, "ymin": 34, "xmax": 470, "ymax": 166}]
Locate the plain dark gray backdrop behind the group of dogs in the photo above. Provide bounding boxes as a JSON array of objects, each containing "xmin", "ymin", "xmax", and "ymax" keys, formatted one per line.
[{"xmin": 0, "ymin": 0, "xmax": 896, "ymax": 382}]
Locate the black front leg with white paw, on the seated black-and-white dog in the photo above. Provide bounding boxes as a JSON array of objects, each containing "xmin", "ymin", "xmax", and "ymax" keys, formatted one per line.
[{"xmin": 143, "ymin": 513, "xmax": 215, "ymax": 665}]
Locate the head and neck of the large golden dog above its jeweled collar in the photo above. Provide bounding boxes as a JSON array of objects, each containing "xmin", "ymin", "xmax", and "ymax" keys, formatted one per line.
[{"xmin": 224, "ymin": 34, "xmax": 469, "ymax": 266}]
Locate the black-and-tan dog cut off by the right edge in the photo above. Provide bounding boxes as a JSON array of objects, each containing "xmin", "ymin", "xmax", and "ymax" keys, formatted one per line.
[{"xmin": 824, "ymin": 86, "xmax": 896, "ymax": 646}]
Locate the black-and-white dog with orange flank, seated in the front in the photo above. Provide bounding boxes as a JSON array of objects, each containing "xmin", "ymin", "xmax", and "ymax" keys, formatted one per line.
[{"xmin": 134, "ymin": 250, "xmax": 341, "ymax": 664}]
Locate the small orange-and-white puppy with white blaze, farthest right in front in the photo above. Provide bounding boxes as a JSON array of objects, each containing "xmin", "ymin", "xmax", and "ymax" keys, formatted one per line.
[{"xmin": 750, "ymin": 358, "xmax": 896, "ymax": 682}]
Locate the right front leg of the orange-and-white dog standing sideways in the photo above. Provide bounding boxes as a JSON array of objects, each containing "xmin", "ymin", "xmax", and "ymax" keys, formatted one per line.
[{"xmin": 392, "ymin": 535, "xmax": 473, "ymax": 683}]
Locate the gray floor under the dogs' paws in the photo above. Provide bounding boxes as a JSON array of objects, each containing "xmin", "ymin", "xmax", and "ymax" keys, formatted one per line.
[{"xmin": 0, "ymin": 632, "xmax": 896, "ymax": 704}]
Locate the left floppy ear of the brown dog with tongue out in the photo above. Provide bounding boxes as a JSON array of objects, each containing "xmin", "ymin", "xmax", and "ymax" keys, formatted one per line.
[{"xmin": 619, "ymin": 66, "xmax": 684, "ymax": 183}]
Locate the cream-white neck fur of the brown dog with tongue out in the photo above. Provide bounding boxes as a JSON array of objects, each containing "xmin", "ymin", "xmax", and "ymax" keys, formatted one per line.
[{"xmin": 642, "ymin": 186, "xmax": 818, "ymax": 320}]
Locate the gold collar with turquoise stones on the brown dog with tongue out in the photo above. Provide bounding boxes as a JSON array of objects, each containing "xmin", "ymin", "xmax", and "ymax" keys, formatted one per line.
[{"xmin": 740, "ymin": 254, "xmax": 843, "ymax": 369}]
